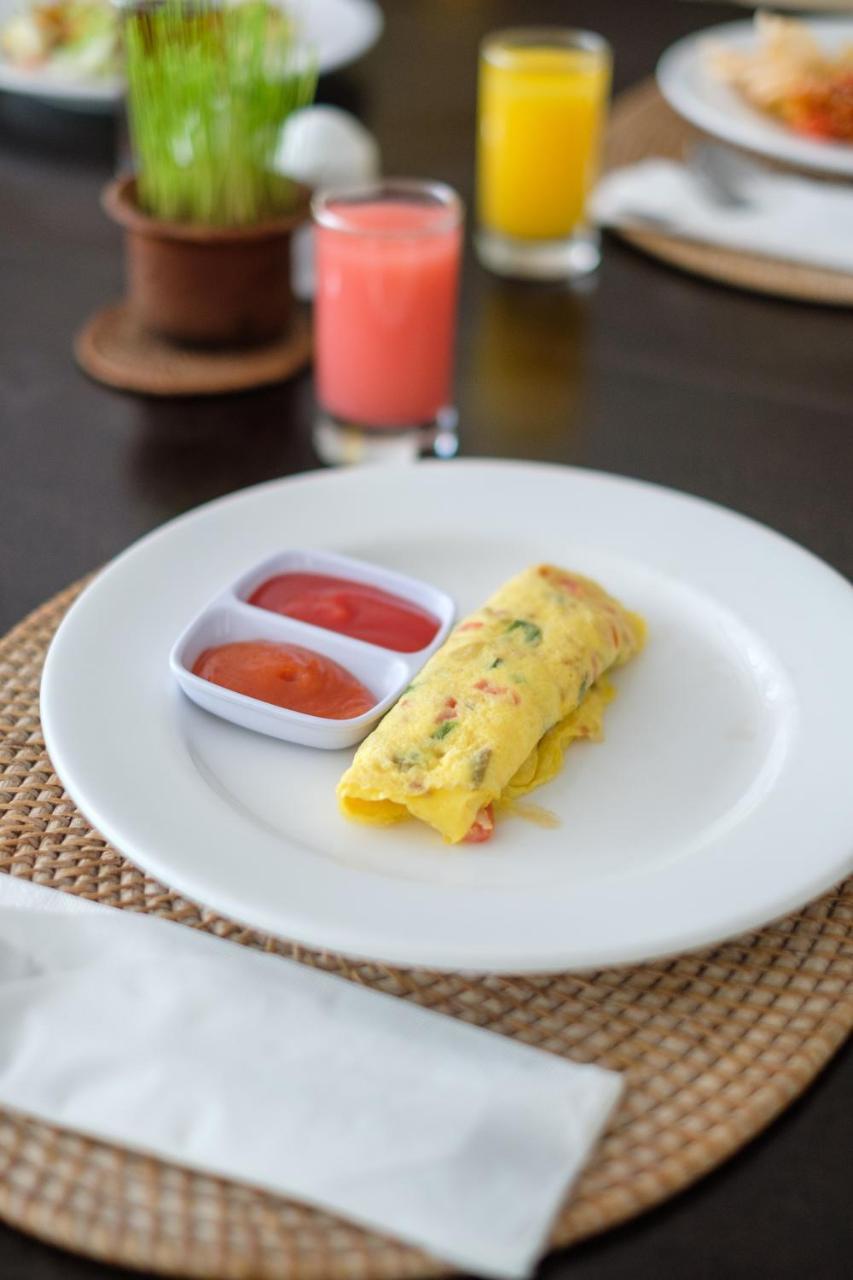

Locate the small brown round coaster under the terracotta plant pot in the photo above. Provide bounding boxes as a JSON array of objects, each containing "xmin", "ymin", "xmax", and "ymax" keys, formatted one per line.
[{"xmin": 74, "ymin": 302, "xmax": 311, "ymax": 396}]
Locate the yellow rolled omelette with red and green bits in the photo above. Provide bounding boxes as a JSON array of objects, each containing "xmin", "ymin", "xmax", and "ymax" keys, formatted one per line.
[{"xmin": 337, "ymin": 564, "xmax": 646, "ymax": 844}]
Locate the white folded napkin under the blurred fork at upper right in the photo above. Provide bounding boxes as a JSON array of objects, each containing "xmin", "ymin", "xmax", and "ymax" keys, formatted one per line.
[{"xmin": 593, "ymin": 159, "xmax": 853, "ymax": 271}]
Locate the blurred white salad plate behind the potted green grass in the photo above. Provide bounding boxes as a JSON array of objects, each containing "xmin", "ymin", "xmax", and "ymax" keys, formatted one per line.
[{"xmin": 0, "ymin": 0, "xmax": 384, "ymax": 113}]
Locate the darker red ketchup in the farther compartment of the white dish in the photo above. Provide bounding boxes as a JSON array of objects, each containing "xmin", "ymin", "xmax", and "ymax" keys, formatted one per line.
[{"xmin": 248, "ymin": 573, "xmax": 439, "ymax": 653}]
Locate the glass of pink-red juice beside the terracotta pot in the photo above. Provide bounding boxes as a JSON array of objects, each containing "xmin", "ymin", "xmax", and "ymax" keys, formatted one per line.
[{"xmin": 314, "ymin": 179, "xmax": 464, "ymax": 461}]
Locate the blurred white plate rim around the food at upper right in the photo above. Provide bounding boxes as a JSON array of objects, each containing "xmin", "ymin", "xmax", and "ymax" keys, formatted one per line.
[{"xmin": 657, "ymin": 18, "xmax": 853, "ymax": 177}]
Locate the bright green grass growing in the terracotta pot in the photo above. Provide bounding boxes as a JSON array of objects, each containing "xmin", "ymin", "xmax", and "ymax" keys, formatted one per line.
[{"xmin": 124, "ymin": 0, "xmax": 316, "ymax": 227}]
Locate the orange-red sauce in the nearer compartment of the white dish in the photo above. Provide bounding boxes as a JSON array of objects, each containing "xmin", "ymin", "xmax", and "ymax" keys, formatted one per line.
[{"xmin": 192, "ymin": 640, "xmax": 377, "ymax": 719}]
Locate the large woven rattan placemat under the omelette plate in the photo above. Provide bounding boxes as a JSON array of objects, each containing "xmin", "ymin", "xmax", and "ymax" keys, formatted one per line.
[{"xmin": 0, "ymin": 585, "xmax": 853, "ymax": 1280}]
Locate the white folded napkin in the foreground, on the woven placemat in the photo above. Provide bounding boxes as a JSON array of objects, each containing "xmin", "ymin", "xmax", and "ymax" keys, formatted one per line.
[{"xmin": 0, "ymin": 874, "xmax": 621, "ymax": 1276}]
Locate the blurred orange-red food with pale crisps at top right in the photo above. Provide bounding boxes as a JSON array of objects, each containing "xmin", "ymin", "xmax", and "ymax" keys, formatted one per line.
[{"xmin": 710, "ymin": 13, "xmax": 853, "ymax": 142}]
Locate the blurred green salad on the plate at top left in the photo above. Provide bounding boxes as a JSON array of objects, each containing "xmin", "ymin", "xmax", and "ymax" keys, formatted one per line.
[{"xmin": 0, "ymin": 0, "xmax": 122, "ymax": 79}]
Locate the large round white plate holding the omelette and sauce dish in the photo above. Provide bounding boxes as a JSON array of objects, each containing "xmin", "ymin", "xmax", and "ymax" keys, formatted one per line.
[{"xmin": 42, "ymin": 462, "xmax": 853, "ymax": 972}]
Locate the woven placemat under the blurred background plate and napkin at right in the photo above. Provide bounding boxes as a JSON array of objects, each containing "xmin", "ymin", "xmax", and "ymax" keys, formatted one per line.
[{"xmin": 605, "ymin": 79, "xmax": 853, "ymax": 306}]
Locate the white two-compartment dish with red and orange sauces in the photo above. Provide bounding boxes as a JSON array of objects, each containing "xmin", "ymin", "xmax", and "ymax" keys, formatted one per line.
[{"xmin": 169, "ymin": 550, "xmax": 455, "ymax": 749}]
